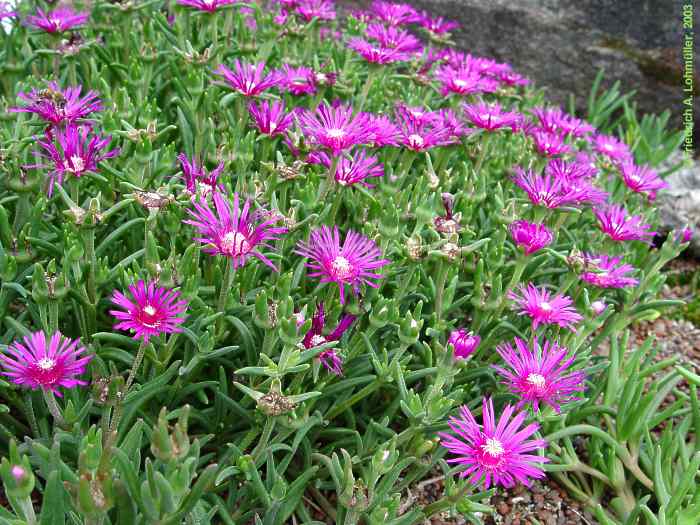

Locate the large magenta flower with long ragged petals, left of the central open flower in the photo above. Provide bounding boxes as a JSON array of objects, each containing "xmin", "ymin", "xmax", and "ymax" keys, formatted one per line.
[{"xmin": 184, "ymin": 192, "xmax": 287, "ymax": 271}]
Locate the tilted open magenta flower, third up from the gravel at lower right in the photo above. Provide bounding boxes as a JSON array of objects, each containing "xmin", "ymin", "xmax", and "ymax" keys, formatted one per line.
[{"xmin": 508, "ymin": 283, "xmax": 583, "ymax": 331}]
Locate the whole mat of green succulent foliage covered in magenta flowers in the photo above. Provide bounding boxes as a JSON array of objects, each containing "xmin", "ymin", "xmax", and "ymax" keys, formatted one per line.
[{"xmin": 0, "ymin": 0, "xmax": 700, "ymax": 525}]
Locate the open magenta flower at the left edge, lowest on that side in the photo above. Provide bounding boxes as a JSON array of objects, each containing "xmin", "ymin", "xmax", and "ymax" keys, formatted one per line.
[{"xmin": 0, "ymin": 331, "xmax": 92, "ymax": 397}]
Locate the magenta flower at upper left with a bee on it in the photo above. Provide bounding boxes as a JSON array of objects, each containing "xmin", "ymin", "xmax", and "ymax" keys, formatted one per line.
[{"xmin": 10, "ymin": 81, "xmax": 102, "ymax": 125}]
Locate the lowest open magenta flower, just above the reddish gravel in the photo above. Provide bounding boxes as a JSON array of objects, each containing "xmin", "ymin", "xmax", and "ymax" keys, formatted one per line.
[{"xmin": 438, "ymin": 398, "xmax": 549, "ymax": 488}]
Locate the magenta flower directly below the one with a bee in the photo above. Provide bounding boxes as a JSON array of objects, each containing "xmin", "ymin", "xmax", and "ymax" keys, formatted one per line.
[{"xmin": 27, "ymin": 124, "xmax": 119, "ymax": 197}]
